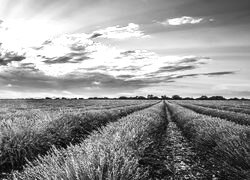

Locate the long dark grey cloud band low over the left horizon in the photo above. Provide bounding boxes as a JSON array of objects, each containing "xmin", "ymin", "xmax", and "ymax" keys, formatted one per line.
[{"xmin": 0, "ymin": 69, "xmax": 147, "ymax": 91}]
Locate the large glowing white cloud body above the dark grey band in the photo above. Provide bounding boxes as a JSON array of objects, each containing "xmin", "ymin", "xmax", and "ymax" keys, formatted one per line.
[{"xmin": 0, "ymin": 31, "xmax": 213, "ymax": 81}]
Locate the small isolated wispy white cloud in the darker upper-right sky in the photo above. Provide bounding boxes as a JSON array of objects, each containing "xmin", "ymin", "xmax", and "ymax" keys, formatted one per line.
[{"xmin": 159, "ymin": 16, "xmax": 205, "ymax": 26}]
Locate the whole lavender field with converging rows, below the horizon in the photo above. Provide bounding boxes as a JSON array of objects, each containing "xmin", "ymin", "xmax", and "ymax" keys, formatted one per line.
[{"xmin": 0, "ymin": 100, "xmax": 250, "ymax": 180}]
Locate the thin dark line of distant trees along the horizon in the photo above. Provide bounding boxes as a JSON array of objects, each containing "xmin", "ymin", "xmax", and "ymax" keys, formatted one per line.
[{"xmin": 42, "ymin": 94, "xmax": 249, "ymax": 100}]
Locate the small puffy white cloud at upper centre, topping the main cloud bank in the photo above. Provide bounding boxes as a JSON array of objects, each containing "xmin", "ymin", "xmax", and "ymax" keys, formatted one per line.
[{"xmin": 90, "ymin": 23, "xmax": 148, "ymax": 40}]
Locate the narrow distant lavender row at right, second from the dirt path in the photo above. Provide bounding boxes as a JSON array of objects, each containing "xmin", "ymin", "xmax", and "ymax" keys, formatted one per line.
[{"xmin": 179, "ymin": 103, "xmax": 250, "ymax": 125}]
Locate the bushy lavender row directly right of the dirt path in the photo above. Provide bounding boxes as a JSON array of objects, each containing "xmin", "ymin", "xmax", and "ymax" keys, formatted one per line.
[{"xmin": 167, "ymin": 103, "xmax": 250, "ymax": 178}]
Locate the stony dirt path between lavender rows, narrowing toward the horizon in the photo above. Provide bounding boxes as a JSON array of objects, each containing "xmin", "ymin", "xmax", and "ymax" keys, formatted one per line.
[{"xmin": 140, "ymin": 107, "xmax": 219, "ymax": 180}]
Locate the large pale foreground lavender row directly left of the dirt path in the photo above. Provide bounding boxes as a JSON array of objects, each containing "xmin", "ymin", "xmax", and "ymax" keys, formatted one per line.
[{"xmin": 12, "ymin": 103, "xmax": 165, "ymax": 180}]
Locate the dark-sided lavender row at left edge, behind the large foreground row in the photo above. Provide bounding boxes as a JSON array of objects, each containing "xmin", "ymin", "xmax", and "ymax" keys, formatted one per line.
[{"xmin": 0, "ymin": 102, "xmax": 155, "ymax": 173}]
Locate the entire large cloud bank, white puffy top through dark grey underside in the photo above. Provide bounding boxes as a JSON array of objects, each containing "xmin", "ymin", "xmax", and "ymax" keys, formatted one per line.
[{"xmin": 0, "ymin": 23, "xmax": 225, "ymax": 97}]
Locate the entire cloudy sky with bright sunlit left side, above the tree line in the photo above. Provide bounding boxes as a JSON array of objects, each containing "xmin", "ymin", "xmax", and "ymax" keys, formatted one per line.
[{"xmin": 0, "ymin": 0, "xmax": 250, "ymax": 98}]
